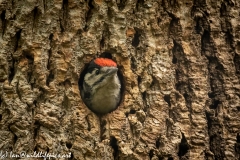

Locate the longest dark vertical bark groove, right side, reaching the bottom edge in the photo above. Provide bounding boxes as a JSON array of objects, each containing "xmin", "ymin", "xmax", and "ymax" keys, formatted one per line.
[{"xmin": 202, "ymin": 28, "xmax": 225, "ymax": 159}]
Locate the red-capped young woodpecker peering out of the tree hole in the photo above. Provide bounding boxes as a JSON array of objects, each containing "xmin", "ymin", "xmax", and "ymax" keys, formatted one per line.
[{"xmin": 80, "ymin": 58, "xmax": 121, "ymax": 114}]
